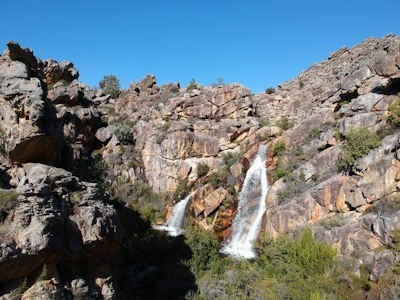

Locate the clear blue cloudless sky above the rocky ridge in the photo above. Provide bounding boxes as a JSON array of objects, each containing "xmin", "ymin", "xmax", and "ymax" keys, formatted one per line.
[{"xmin": 0, "ymin": 0, "xmax": 400, "ymax": 93}]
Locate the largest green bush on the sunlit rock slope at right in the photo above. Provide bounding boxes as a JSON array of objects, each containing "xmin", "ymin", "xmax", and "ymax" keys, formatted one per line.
[{"xmin": 337, "ymin": 127, "xmax": 380, "ymax": 171}]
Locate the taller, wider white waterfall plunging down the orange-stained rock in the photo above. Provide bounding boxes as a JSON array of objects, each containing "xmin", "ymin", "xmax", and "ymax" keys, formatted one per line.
[{"xmin": 221, "ymin": 145, "xmax": 268, "ymax": 259}]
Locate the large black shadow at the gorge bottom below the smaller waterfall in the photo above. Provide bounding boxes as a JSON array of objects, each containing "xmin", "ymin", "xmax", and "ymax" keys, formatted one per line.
[{"xmin": 114, "ymin": 203, "xmax": 197, "ymax": 299}]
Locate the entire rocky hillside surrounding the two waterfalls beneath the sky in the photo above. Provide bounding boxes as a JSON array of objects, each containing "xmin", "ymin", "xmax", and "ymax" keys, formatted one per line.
[{"xmin": 0, "ymin": 35, "xmax": 400, "ymax": 299}]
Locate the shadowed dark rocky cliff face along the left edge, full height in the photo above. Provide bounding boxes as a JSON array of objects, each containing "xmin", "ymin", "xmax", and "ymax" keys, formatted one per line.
[{"xmin": 0, "ymin": 43, "xmax": 123, "ymax": 299}]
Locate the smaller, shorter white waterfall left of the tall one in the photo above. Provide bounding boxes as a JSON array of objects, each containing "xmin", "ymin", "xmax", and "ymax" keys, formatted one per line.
[{"xmin": 154, "ymin": 192, "xmax": 194, "ymax": 236}]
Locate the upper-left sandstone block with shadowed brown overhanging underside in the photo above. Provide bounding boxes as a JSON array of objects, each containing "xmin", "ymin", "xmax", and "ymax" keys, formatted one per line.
[{"xmin": 0, "ymin": 54, "xmax": 64, "ymax": 164}]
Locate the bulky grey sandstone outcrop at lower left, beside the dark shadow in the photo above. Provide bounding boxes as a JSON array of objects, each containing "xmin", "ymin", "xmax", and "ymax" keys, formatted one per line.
[{"xmin": 0, "ymin": 163, "xmax": 123, "ymax": 281}]
